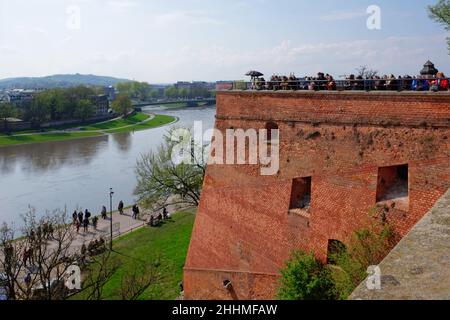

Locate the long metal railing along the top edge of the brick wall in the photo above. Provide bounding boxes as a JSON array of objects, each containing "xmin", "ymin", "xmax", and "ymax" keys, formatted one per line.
[{"xmin": 220, "ymin": 78, "xmax": 450, "ymax": 92}]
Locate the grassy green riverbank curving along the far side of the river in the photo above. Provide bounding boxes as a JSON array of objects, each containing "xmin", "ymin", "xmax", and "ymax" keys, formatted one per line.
[{"xmin": 0, "ymin": 112, "xmax": 178, "ymax": 147}]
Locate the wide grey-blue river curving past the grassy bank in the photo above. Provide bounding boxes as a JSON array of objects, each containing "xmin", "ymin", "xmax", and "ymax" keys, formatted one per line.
[{"xmin": 0, "ymin": 106, "xmax": 215, "ymax": 225}]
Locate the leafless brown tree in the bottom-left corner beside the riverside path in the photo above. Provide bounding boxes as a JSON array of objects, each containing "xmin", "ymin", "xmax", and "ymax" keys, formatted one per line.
[{"xmin": 0, "ymin": 209, "xmax": 76, "ymax": 300}]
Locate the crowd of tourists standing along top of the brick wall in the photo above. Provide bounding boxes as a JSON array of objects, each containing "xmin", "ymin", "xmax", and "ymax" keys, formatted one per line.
[{"xmin": 251, "ymin": 72, "xmax": 449, "ymax": 92}]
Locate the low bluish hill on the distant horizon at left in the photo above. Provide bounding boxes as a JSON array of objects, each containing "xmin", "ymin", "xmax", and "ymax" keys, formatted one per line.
[{"xmin": 0, "ymin": 73, "xmax": 130, "ymax": 90}]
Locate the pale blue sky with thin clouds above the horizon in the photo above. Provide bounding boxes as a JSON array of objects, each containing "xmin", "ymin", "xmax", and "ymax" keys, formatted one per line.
[{"xmin": 0, "ymin": 0, "xmax": 450, "ymax": 83}]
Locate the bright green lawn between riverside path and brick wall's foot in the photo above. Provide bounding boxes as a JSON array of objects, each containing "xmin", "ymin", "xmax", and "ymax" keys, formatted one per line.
[{"xmin": 75, "ymin": 212, "xmax": 195, "ymax": 300}]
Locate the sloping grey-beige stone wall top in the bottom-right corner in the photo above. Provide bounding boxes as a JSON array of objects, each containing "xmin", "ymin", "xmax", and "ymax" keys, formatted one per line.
[{"xmin": 350, "ymin": 189, "xmax": 450, "ymax": 300}]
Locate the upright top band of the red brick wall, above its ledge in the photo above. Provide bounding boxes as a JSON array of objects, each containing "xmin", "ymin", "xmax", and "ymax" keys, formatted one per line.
[{"xmin": 216, "ymin": 91, "xmax": 450, "ymax": 129}]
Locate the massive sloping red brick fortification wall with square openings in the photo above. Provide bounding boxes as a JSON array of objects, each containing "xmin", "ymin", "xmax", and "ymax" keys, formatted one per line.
[{"xmin": 184, "ymin": 91, "xmax": 450, "ymax": 299}]
